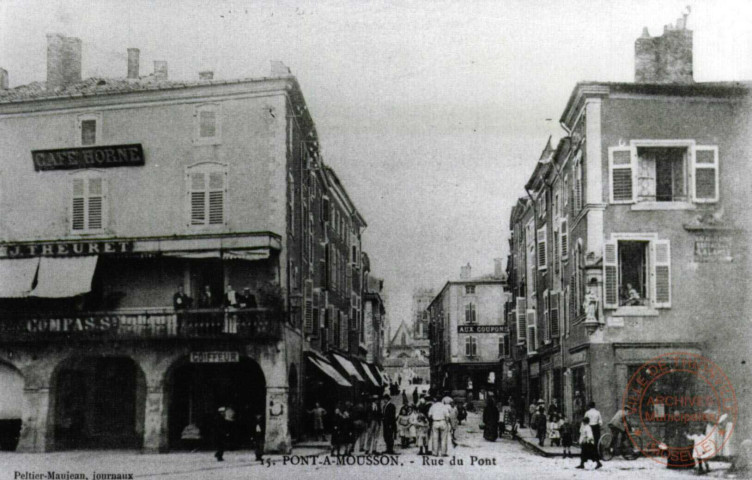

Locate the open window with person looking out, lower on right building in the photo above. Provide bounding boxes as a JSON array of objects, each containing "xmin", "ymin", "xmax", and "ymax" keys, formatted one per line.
[{"xmin": 603, "ymin": 239, "xmax": 671, "ymax": 308}]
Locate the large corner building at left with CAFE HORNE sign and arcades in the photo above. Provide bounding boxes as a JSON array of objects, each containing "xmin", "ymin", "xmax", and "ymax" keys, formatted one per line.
[{"xmin": 0, "ymin": 35, "xmax": 374, "ymax": 452}]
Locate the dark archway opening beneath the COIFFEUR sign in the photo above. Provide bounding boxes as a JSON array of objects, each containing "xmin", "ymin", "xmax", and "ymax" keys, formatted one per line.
[{"xmin": 165, "ymin": 357, "xmax": 266, "ymax": 450}]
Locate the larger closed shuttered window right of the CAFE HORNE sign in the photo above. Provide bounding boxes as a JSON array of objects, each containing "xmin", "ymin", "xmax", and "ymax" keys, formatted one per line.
[{"xmin": 186, "ymin": 163, "xmax": 227, "ymax": 227}]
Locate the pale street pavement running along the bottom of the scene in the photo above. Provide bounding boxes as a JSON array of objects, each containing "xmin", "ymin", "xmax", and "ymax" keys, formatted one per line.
[{"xmin": 0, "ymin": 402, "xmax": 733, "ymax": 480}]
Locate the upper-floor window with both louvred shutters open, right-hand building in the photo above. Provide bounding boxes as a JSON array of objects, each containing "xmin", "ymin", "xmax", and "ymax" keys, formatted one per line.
[{"xmin": 609, "ymin": 140, "xmax": 719, "ymax": 207}]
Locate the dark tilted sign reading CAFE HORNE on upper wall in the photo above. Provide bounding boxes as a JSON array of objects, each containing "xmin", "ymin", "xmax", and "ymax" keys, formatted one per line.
[{"xmin": 31, "ymin": 143, "xmax": 144, "ymax": 172}]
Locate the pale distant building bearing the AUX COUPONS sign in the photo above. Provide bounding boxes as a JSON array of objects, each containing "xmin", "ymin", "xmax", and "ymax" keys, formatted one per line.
[{"xmin": 428, "ymin": 265, "xmax": 510, "ymax": 399}]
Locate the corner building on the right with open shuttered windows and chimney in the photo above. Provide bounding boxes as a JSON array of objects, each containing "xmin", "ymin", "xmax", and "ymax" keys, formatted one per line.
[{"xmin": 507, "ymin": 18, "xmax": 752, "ymax": 438}]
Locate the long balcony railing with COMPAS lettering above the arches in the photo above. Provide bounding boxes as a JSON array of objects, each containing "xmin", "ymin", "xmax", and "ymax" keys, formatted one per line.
[{"xmin": 0, "ymin": 308, "xmax": 284, "ymax": 341}]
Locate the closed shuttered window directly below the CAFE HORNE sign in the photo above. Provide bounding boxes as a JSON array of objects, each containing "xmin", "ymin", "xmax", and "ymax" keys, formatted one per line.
[{"xmin": 71, "ymin": 171, "xmax": 107, "ymax": 233}]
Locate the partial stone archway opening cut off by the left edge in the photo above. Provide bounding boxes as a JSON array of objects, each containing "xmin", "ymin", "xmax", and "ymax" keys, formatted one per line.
[{"xmin": 0, "ymin": 362, "xmax": 24, "ymax": 450}]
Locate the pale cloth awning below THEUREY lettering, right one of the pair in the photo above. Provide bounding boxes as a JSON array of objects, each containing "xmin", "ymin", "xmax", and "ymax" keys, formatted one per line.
[{"xmin": 30, "ymin": 255, "xmax": 99, "ymax": 298}]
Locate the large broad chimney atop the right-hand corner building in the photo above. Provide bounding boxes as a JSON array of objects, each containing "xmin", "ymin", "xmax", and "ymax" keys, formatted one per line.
[{"xmin": 635, "ymin": 14, "xmax": 694, "ymax": 84}]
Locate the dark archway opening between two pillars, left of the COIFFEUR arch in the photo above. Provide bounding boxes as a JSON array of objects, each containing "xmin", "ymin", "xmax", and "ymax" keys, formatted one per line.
[{"xmin": 48, "ymin": 356, "xmax": 146, "ymax": 450}]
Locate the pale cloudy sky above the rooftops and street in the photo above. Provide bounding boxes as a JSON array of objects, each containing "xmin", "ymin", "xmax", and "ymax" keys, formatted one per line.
[{"xmin": 0, "ymin": 0, "xmax": 752, "ymax": 330}]
